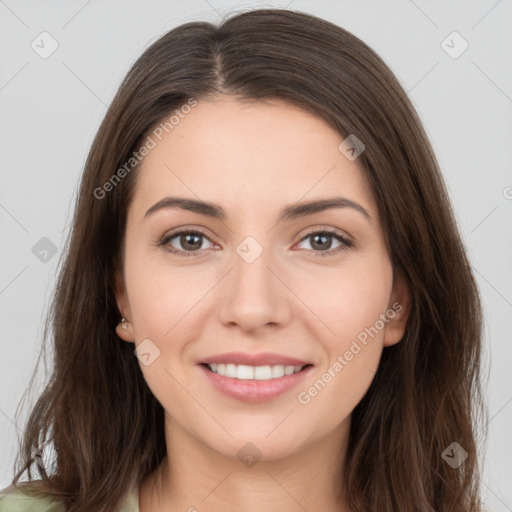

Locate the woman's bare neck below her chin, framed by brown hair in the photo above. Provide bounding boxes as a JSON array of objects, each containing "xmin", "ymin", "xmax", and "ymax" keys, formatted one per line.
[{"xmin": 139, "ymin": 417, "xmax": 350, "ymax": 512}]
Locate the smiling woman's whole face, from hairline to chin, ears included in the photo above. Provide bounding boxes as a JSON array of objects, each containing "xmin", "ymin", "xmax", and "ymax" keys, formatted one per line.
[{"xmin": 117, "ymin": 97, "xmax": 408, "ymax": 460}]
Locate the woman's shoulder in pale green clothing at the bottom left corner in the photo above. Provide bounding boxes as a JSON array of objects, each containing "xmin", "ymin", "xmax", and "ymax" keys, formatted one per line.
[{"xmin": 0, "ymin": 482, "xmax": 65, "ymax": 512}]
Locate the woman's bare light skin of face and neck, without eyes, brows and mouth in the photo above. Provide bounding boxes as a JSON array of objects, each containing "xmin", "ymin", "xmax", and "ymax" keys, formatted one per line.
[{"xmin": 116, "ymin": 96, "xmax": 409, "ymax": 512}]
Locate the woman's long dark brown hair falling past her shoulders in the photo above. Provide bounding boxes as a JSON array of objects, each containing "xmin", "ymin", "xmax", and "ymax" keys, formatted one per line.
[{"xmin": 4, "ymin": 9, "xmax": 486, "ymax": 512}]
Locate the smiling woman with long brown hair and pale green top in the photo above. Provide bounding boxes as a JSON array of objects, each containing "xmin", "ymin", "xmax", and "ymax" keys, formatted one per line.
[{"xmin": 0, "ymin": 9, "xmax": 488, "ymax": 512}]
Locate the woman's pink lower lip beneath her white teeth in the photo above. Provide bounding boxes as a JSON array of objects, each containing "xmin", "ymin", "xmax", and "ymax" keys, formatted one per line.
[{"xmin": 199, "ymin": 365, "xmax": 313, "ymax": 403}]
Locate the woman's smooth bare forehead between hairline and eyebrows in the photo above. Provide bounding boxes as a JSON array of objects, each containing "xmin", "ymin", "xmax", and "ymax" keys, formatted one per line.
[{"xmin": 133, "ymin": 97, "xmax": 375, "ymax": 221}]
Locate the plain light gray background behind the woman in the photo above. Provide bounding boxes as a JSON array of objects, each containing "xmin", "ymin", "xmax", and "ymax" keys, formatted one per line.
[{"xmin": 0, "ymin": 0, "xmax": 512, "ymax": 512}]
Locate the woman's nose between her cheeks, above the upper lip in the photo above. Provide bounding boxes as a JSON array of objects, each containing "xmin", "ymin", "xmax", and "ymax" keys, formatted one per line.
[{"xmin": 218, "ymin": 246, "xmax": 292, "ymax": 333}]
